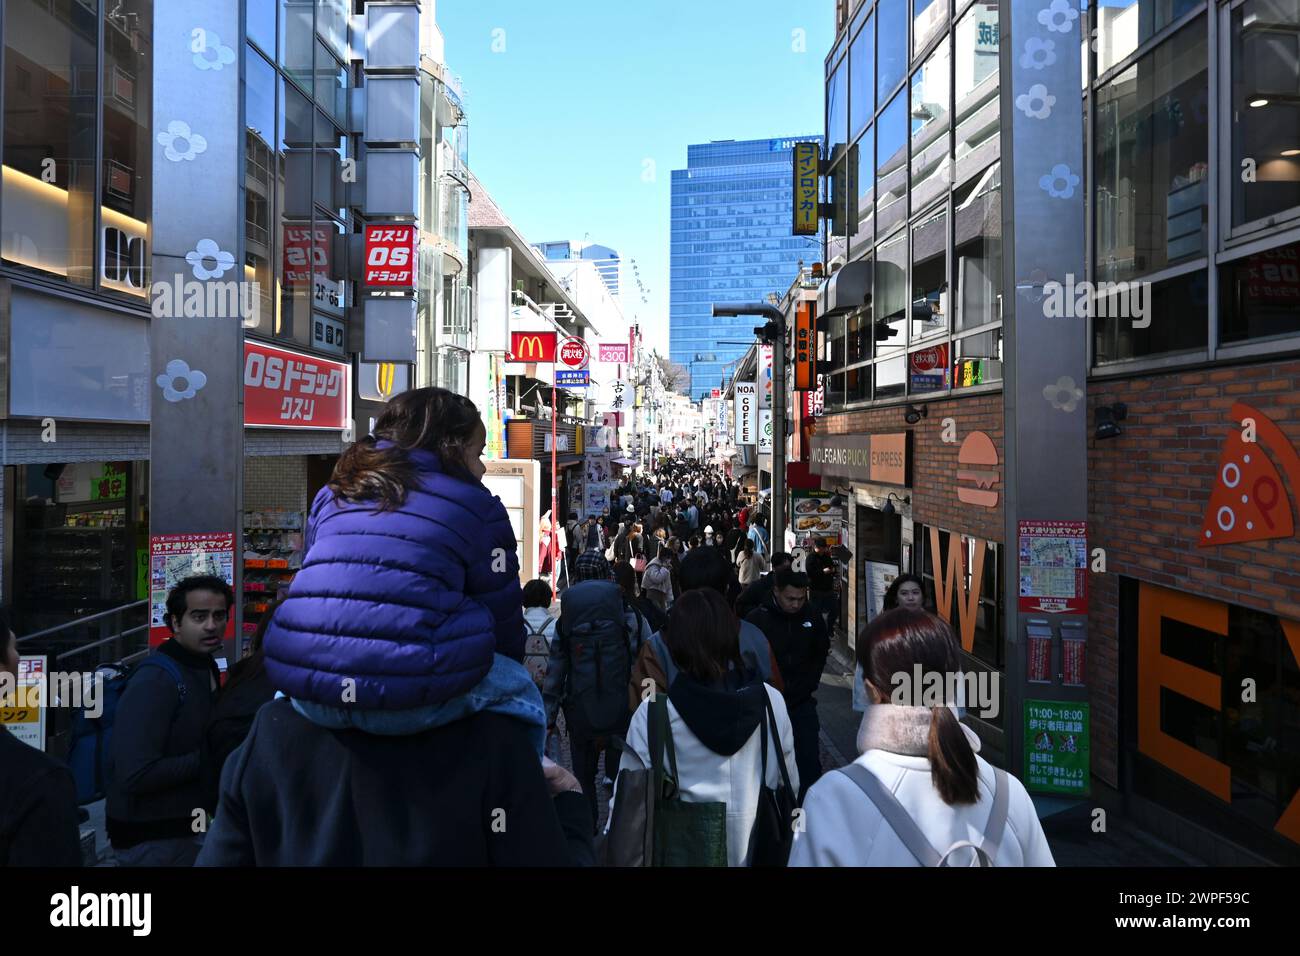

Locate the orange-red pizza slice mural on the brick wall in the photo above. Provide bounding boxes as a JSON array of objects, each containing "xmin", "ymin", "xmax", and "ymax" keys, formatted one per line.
[{"xmin": 1197, "ymin": 403, "xmax": 1300, "ymax": 548}]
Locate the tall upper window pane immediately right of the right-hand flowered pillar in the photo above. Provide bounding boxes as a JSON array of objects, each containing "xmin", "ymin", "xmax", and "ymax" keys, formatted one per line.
[{"xmin": 1091, "ymin": 17, "xmax": 1209, "ymax": 281}]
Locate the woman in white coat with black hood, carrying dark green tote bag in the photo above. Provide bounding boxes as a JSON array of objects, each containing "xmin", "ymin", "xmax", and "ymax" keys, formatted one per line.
[{"xmin": 611, "ymin": 588, "xmax": 800, "ymax": 866}]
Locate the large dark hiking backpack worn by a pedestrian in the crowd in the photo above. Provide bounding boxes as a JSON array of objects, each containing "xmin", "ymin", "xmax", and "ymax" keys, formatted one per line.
[{"xmin": 556, "ymin": 581, "xmax": 642, "ymax": 736}]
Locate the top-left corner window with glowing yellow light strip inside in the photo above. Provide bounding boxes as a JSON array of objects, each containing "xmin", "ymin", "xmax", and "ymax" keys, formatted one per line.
[{"xmin": 0, "ymin": 3, "xmax": 98, "ymax": 287}]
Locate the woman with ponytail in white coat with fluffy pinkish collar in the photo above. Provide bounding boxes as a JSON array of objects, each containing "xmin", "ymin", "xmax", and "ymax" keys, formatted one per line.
[{"xmin": 790, "ymin": 609, "xmax": 1056, "ymax": 866}]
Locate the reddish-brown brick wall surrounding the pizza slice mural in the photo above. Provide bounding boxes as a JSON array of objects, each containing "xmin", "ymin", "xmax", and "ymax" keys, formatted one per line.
[{"xmin": 1088, "ymin": 360, "xmax": 1300, "ymax": 784}]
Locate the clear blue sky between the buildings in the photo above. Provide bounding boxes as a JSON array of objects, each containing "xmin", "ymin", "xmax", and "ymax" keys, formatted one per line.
[{"xmin": 437, "ymin": 0, "xmax": 835, "ymax": 352}]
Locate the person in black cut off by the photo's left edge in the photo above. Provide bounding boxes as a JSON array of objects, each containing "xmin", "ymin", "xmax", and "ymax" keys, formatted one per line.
[{"xmin": 0, "ymin": 609, "xmax": 82, "ymax": 868}]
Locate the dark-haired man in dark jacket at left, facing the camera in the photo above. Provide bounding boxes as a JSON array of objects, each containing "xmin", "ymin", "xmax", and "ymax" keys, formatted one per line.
[{"xmin": 107, "ymin": 575, "xmax": 228, "ymax": 866}]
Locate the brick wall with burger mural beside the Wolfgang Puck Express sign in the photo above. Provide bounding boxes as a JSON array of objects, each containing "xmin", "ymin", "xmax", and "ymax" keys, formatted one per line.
[{"xmin": 818, "ymin": 393, "xmax": 1006, "ymax": 542}]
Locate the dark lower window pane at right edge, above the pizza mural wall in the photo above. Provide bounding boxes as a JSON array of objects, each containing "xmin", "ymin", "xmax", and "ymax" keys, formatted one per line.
[{"xmin": 1219, "ymin": 242, "xmax": 1300, "ymax": 345}]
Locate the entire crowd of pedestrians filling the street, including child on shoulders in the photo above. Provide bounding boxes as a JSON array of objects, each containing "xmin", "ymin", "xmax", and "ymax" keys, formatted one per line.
[{"xmin": 0, "ymin": 388, "xmax": 1052, "ymax": 866}]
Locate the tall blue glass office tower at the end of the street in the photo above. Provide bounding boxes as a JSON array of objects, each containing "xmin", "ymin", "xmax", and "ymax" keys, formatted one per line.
[{"xmin": 668, "ymin": 135, "xmax": 822, "ymax": 398}]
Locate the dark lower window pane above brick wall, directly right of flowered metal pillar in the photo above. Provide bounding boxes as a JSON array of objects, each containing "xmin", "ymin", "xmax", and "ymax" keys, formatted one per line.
[{"xmin": 1086, "ymin": 269, "xmax": 1209, "ymax": 365}]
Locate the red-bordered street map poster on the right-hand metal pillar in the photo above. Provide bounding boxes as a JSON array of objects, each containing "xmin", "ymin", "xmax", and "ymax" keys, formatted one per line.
[{"xmin": 1019, "ymin": 522, "xmax": 1088, "ymax": 614}]
